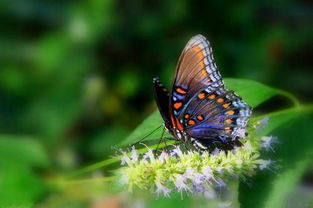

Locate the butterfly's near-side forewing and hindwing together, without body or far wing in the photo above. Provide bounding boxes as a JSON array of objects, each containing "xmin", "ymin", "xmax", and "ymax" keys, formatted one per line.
[{"xmin": 169, "ymin": 35, "xmax": 251, "ymax": 146}]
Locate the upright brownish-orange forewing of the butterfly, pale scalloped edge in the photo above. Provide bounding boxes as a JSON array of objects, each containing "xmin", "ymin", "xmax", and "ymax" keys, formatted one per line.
[{"xmin": 170, "ymin": 35, "xmax": 224, "ymax": 117}]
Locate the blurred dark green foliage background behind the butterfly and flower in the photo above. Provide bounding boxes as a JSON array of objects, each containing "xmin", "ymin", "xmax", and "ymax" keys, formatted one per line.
[{"xmin": 0, "ymin": 0, "xmax": 313, "ymax": 207}]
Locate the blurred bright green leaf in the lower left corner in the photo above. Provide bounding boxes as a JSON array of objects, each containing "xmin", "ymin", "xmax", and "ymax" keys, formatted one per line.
[{"xmin": 0, "ymin": 135, "xmax": 49, "ymax": 207}]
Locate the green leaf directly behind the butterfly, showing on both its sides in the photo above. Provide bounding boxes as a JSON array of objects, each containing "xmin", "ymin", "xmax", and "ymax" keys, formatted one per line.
[{"xmin": 121, "ymin": 79, "xmax": 276, "ymax": 145}]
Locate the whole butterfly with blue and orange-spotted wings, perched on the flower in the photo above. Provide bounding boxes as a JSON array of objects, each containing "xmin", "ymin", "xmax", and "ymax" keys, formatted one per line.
[{"xmin": 153, "ymin": 35, "xmax": 252, "ymax": 151}]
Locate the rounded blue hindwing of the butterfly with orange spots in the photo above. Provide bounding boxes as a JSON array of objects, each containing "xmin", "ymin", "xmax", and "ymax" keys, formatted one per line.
[{"xmin": 184, "ymin": 87, "xmax": 251, "ymax": 139}]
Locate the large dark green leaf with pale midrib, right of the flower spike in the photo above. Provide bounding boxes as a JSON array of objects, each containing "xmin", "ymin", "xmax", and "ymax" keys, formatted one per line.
[{"xmin": 239, "ymin": 106, "xmax": 313, "ymax": 207}]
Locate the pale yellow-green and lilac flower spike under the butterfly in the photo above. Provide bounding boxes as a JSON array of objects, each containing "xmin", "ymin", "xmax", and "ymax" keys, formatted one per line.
[{"xmin": 120, "ymin": 137, "xmax": 272, "ymax": 197}]
